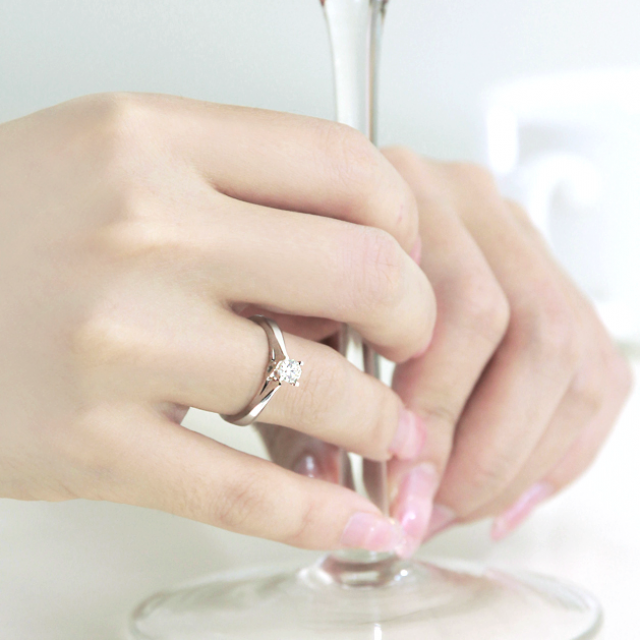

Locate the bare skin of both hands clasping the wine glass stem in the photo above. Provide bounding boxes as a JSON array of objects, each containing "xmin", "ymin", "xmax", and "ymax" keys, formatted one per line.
[{"xmin": 0, "ymin": 94, "xmax": 630, "ymax": 555}]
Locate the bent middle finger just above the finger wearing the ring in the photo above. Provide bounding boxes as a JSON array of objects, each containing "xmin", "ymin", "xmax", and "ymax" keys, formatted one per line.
[{"xmin": 198, "ymin": 201, "xmax": 435, "ymax": 361}]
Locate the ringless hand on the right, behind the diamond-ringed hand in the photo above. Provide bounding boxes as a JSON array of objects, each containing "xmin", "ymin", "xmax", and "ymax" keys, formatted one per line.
[{"xmin": 262, "ymin": 148, "xmax": 631, "ymax": 556}]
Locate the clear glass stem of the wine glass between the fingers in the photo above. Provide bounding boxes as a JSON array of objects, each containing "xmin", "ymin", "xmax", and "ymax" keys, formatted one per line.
[{"xmin": 321, "ymin": 0, "xmax": 390, "ymax": 565}]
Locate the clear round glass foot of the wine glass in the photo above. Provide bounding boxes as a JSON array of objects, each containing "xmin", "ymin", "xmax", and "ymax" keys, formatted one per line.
[{"xmin": 130, "ymin": 553, "xmax": 601, "ymax": 640}]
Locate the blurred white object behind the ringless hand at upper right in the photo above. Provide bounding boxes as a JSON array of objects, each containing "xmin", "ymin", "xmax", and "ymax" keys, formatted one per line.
[{"xmin": 484, "ymin": 68, "xmax": 640, "ymax": 347}]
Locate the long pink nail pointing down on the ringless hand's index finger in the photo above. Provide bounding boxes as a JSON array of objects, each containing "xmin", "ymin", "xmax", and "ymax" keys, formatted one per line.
[{"xmin": 394, "ymin": 463, "xmax": 438, "ymax": 558}]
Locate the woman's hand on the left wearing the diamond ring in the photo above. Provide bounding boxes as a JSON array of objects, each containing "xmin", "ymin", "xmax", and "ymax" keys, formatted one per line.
[{"xmin": 0, "ymin": 94, "xmax": 435, "ymax": 550}]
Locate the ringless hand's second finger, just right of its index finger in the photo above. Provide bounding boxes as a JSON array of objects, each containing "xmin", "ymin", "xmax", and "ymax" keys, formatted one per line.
[{"xmin": 436, "ymin": 165, "xmax": 582, "ymax": 519}]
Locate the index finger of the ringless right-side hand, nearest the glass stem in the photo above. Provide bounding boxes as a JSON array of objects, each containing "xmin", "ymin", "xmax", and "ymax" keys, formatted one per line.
[{"xmin": 385, "ymin": 148, "xmax": 509, "ymax": 547}]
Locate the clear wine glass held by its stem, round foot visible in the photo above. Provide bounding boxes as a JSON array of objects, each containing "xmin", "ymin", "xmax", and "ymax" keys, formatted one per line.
[{"xmin": 130, "ymin": 0, "xmax": 601, "ymax": 640}]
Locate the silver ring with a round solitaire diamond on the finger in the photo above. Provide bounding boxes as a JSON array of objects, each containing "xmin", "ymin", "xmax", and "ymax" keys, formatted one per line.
[{"xmin": 220, "ymin": 315, "xmax": 304, "ymax": 427}]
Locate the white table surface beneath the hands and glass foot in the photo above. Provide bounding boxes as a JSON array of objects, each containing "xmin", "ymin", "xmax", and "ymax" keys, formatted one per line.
[{"xmin": 0, "ymin": 363, "xmax": 640, "ymax": 640}]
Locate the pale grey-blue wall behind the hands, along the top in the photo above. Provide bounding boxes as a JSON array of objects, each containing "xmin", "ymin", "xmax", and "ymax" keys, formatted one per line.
[{"xmin": 0, "ymin": 0, "xmax": 640, "ymax": 159}]
